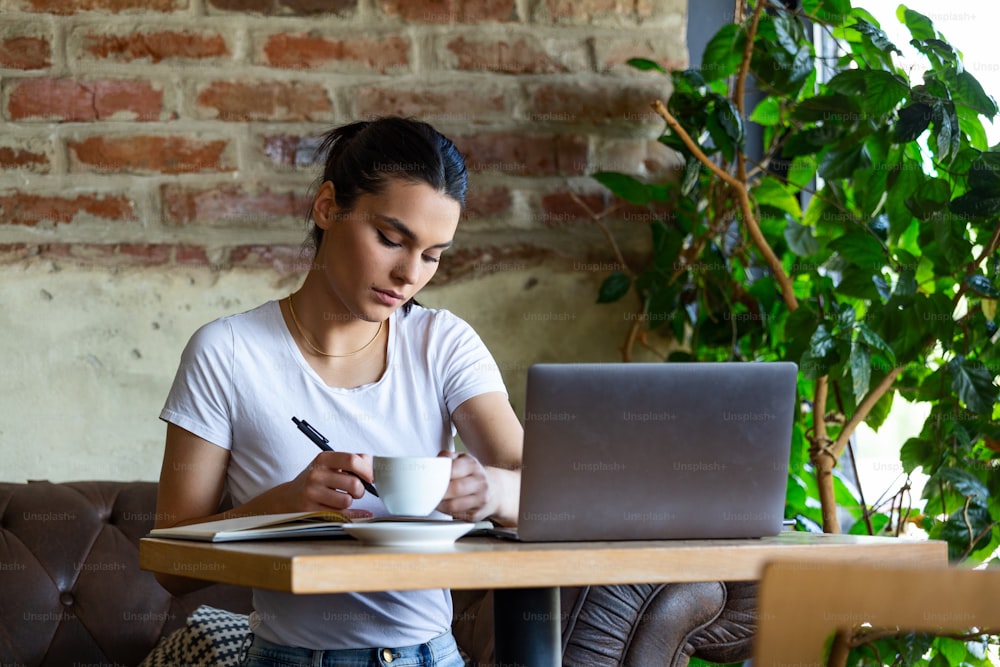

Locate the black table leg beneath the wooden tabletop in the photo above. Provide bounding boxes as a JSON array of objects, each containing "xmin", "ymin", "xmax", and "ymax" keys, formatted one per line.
[{"xmin": 493, "ymin": 586, "xmax": 562, "ymax": 667}]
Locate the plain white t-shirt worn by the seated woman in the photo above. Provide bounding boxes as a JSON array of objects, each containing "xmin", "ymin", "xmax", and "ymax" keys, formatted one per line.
[{"xmin": 160, "ymin": 301, "xmax": 506, "ymax": 649}]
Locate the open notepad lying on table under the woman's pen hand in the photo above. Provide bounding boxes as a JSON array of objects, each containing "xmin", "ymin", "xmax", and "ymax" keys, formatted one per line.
[{"xmin": 149, "ymin": 511, "xmax": 492, "ymax": 542}]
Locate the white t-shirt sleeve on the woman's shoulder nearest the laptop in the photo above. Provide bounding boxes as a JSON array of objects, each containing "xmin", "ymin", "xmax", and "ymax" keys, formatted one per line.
[{"xmin": 432, "ymin": 310, "xmax": 507, "ymax": 414}]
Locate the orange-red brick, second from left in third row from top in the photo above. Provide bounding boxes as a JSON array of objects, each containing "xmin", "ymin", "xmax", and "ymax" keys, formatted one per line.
[{"xmin": 197, "ymin": 81, "xmax": 333, "ymax": 123}]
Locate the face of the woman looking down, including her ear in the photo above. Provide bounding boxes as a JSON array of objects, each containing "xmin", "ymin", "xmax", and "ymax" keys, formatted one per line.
[{"xmin": 313, "ymin": 178, "xmax": 462, "ymax": 322}]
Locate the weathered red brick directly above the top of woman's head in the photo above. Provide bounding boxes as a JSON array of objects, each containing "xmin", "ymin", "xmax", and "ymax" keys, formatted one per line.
[{"xmin": 354, "ymin": 86, "xmax": 506, "ymax": 124}]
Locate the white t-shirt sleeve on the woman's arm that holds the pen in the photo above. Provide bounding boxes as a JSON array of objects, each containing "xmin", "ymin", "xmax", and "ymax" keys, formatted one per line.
[{"xmin": 160, "ymin": 319, "xmax": 234, "ymax": 449}]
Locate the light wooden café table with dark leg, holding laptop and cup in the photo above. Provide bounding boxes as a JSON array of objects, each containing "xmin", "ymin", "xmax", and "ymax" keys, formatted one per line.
[{"xmin": 139, "ymin": 531, "xmax": 948, "ymax": 665}]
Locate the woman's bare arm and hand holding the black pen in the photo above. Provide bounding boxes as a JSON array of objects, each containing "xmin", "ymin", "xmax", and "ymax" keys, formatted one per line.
[{"xmin": 155, "ymin": 424, "xmax": 372, "ymax": 595}]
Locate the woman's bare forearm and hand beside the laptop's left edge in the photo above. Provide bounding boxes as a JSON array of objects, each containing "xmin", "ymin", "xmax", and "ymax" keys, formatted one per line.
[{"xmin": 438, "ymin": 392, "xmax": 524, "ymax": 526}]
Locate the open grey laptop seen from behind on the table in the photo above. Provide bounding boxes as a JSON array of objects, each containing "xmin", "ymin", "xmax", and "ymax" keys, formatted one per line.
[{"xmin": 498, "ymin": 362, "xmax": 797, "ymax": 542}]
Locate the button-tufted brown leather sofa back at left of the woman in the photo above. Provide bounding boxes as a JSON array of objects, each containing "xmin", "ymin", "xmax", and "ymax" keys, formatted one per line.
[{"xmin": 0, "ymin": 481, "xmax": 250, "ymax": 667}]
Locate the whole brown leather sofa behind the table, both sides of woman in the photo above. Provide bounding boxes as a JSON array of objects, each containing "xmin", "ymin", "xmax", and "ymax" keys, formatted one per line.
[{"xmin": 0, "ymin": 481, "xmax": 755, "ymax": 667}]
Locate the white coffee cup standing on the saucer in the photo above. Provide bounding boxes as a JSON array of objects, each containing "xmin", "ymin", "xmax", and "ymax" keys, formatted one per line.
[{"xmin": 372, "ymin": 456, "xmax": 451, "ymax": 516}]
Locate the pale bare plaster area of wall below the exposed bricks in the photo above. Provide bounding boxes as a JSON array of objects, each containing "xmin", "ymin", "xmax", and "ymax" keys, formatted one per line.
[{"xmin": 0, "ymin": 261, "xmax": 628, "ymax": 481}]
